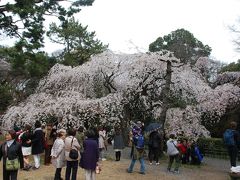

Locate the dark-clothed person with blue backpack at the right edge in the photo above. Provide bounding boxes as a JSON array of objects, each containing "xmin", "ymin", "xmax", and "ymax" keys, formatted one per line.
[{"xmin": 223, "ymin": 121, "xmax": 240, "ymax": 167}]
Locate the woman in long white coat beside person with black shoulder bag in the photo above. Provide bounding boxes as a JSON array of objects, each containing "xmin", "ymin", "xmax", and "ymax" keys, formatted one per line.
[{"xmin": 51, "ymin": 129, "xmax": 66, "ymax": 180}]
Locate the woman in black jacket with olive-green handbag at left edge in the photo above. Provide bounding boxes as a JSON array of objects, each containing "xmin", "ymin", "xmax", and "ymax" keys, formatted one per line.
[{"xmin": 0, "ymin": 130, "xmax": 24, "ymax": 180}]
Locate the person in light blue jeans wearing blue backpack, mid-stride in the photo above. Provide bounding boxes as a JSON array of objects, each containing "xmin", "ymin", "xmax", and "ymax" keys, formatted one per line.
[{"xmin": 127, "ymin": 127, "xmax": 145, "ymax": 174}]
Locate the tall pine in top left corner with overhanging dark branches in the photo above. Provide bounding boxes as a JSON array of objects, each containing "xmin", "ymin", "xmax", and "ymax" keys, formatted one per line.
[{"xmin": 0, "ymin": 0, "xmax": 94, "ymax": 73}]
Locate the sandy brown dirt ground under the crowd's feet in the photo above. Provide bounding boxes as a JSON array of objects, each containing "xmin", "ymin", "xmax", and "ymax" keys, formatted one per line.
[{"xmin": 0, "ymin": 149, "xmax": 232, "ymax": 180}]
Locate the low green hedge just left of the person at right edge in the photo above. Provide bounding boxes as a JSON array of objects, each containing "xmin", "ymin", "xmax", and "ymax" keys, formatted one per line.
[{"xmin": 197, "ymin": 138, "xmax": 228, "ymax": 159}]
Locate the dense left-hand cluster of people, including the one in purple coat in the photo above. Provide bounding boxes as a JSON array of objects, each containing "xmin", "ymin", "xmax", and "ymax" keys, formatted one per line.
[{"xmin": 0, "ymin": 121, "xmax": 110, "ymax": 180}]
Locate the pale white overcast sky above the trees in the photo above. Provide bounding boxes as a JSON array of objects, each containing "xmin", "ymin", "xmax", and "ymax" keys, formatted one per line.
[{"xmin": 0, "ymin": 0, "xmax": 240, "ymax": 63}]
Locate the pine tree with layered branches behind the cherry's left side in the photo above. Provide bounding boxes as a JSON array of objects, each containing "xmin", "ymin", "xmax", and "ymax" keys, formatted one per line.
[{"xmin": 47, "ymin": 18, "xmax": 107, "ymax": 66}]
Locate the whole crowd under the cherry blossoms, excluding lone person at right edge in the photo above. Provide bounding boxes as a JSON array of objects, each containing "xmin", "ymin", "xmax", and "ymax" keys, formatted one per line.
[{"xmin": 0, "ymin": 121, "xmax": 206, "ymax": 180}]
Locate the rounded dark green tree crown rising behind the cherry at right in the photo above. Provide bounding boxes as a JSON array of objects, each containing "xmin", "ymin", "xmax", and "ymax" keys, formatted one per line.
[{"xmin": 149, "ymin": 29, "xmax": 211, "ymax": 64}]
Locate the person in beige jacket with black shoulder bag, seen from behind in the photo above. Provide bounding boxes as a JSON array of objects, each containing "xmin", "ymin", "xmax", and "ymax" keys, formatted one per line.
[{"xmin": 65, "ymin": 129, "xmax": 80, "ymax": 180}]
